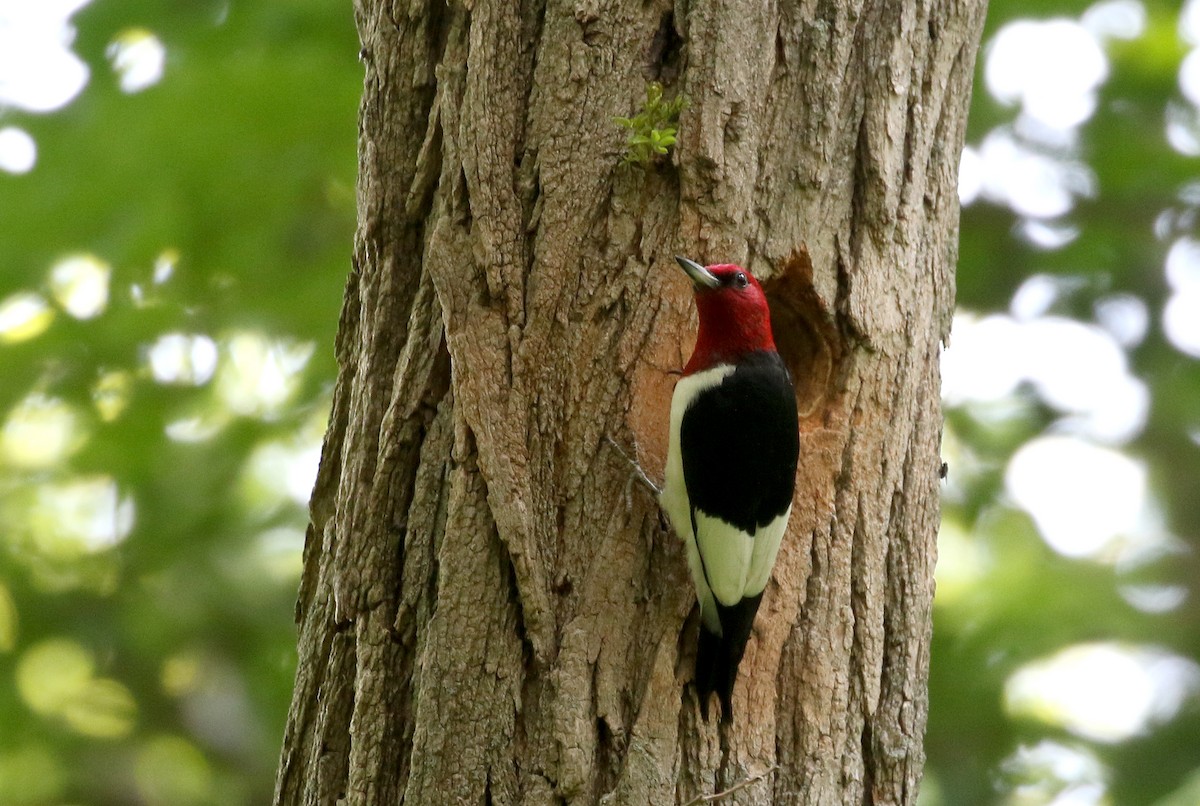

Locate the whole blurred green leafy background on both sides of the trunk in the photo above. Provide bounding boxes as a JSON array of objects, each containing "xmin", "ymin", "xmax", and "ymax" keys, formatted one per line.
[{"xmin": 0, "ymin": 0, "xmax": 1200, "ymax": 806}]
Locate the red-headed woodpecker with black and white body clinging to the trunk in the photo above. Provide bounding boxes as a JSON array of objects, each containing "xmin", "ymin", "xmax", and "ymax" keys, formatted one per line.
[{"xmin": 661, "ymin": 257, "xmax": 799, "ymax": 722}]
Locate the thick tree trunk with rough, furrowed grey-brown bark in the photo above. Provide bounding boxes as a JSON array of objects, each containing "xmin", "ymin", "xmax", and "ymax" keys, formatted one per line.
[{"xmin": 276, "ymin": 0, "xmax": 984, "ymax": 805}]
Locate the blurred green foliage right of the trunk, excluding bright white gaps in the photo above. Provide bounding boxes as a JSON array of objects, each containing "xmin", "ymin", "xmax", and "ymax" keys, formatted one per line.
[{"xmin": 923, "ymin": 0, "xmax": 1200, "ymax": 806}]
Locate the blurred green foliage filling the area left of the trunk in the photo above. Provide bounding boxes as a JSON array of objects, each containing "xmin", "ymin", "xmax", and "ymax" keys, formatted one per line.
[{"xmin": 0, "ymin": 0, "xmax": 362, "ymax": 806}]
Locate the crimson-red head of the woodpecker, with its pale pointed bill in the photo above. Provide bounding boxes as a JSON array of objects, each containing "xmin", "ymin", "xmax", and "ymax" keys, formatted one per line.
[{"xmin": 676, "ymin": 257, "xmax": 775, "ymax": 375}]
